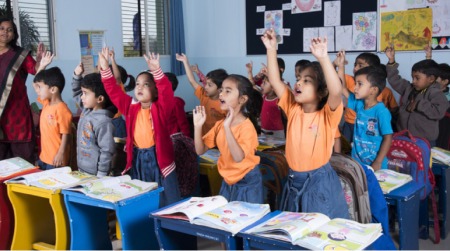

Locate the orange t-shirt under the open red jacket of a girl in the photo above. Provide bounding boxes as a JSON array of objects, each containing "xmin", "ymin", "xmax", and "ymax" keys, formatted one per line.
[{"xmin": 134, "ymin": 108, "xmax": 155, "ymax": 149}]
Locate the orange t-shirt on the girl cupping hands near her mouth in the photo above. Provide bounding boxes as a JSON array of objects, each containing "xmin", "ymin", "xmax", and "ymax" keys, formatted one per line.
[{"xmin": 203, "ymin": 119, "xmax": 259, "ymax": 185}]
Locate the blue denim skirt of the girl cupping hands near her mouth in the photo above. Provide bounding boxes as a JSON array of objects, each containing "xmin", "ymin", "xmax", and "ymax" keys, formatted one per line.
[{"xmin": 219, "ymin": 165, "xmax": 264, "ymax": 204}]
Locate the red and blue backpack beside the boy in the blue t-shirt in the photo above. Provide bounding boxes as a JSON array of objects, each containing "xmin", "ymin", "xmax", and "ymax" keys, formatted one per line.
[{"xmin": 387, "ymin": 130, "xmax": 440, "ymax": 244}]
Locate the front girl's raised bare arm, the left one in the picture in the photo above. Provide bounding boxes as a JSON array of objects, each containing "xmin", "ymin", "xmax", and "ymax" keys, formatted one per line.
[{"xmin": 261, "ymin": 29, "xmax": 286, "ymax": 98}]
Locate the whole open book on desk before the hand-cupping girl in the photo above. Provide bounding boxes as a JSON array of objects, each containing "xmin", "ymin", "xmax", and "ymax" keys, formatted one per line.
[{"xmin": 153, "ymin": 195, "xmax": 270, "ymax": 235}]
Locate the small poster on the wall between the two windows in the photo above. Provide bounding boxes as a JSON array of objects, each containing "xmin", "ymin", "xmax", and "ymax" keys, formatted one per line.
[{"xmin": 80, "ymin": 31, "xmax": 106, "ymax": 75}]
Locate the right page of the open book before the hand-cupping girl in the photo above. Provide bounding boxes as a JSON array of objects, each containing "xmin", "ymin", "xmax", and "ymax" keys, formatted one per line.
[{"xmin": 192, "ymin": 201, "xmax": 270, "ymax": 235}]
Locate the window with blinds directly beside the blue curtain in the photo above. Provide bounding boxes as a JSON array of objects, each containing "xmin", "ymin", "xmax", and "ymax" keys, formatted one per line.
[{"xmin": 122, "ymin": 0, "xmax": 169, "ymax": 57}]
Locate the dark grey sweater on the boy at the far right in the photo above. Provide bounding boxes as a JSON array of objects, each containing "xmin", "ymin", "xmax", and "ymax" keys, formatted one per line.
[{"xmin": 386, "ymin": 63, "xmax": 449, "ymax": 141}]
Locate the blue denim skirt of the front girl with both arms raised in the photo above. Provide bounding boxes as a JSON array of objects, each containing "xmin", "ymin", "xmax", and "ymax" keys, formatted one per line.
[{"xmin": 280, "ymin": 163, "xmax": 349, "ymax": 219}]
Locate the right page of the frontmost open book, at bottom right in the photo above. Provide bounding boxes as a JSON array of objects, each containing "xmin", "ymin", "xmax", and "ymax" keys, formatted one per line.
[{"xmin": 294, "ymin": 218, "xmax": 381, "ymax": 250}]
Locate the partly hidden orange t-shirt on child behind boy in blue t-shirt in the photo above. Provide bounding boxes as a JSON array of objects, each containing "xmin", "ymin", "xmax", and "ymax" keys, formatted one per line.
[{"xmin": 344, "ymin": 74, "xmax": 398, "ymax": 124}]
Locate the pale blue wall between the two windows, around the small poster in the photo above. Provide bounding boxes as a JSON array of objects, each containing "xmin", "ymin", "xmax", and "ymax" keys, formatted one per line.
[{"xmin": 27, "ymin": 0, "xmax": 170, "ymax": 112}]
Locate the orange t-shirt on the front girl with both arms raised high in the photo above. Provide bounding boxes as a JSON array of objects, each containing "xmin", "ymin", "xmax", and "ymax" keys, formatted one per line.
[{"xmin": 278, "ymin": 88, "xmax": 344, "ymax": 172}]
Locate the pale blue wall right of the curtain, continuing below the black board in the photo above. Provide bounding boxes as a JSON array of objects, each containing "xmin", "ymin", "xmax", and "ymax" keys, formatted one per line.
[{"xmin": 183, "ymin": 0, "xmax": 450, "ymax": 108}]
